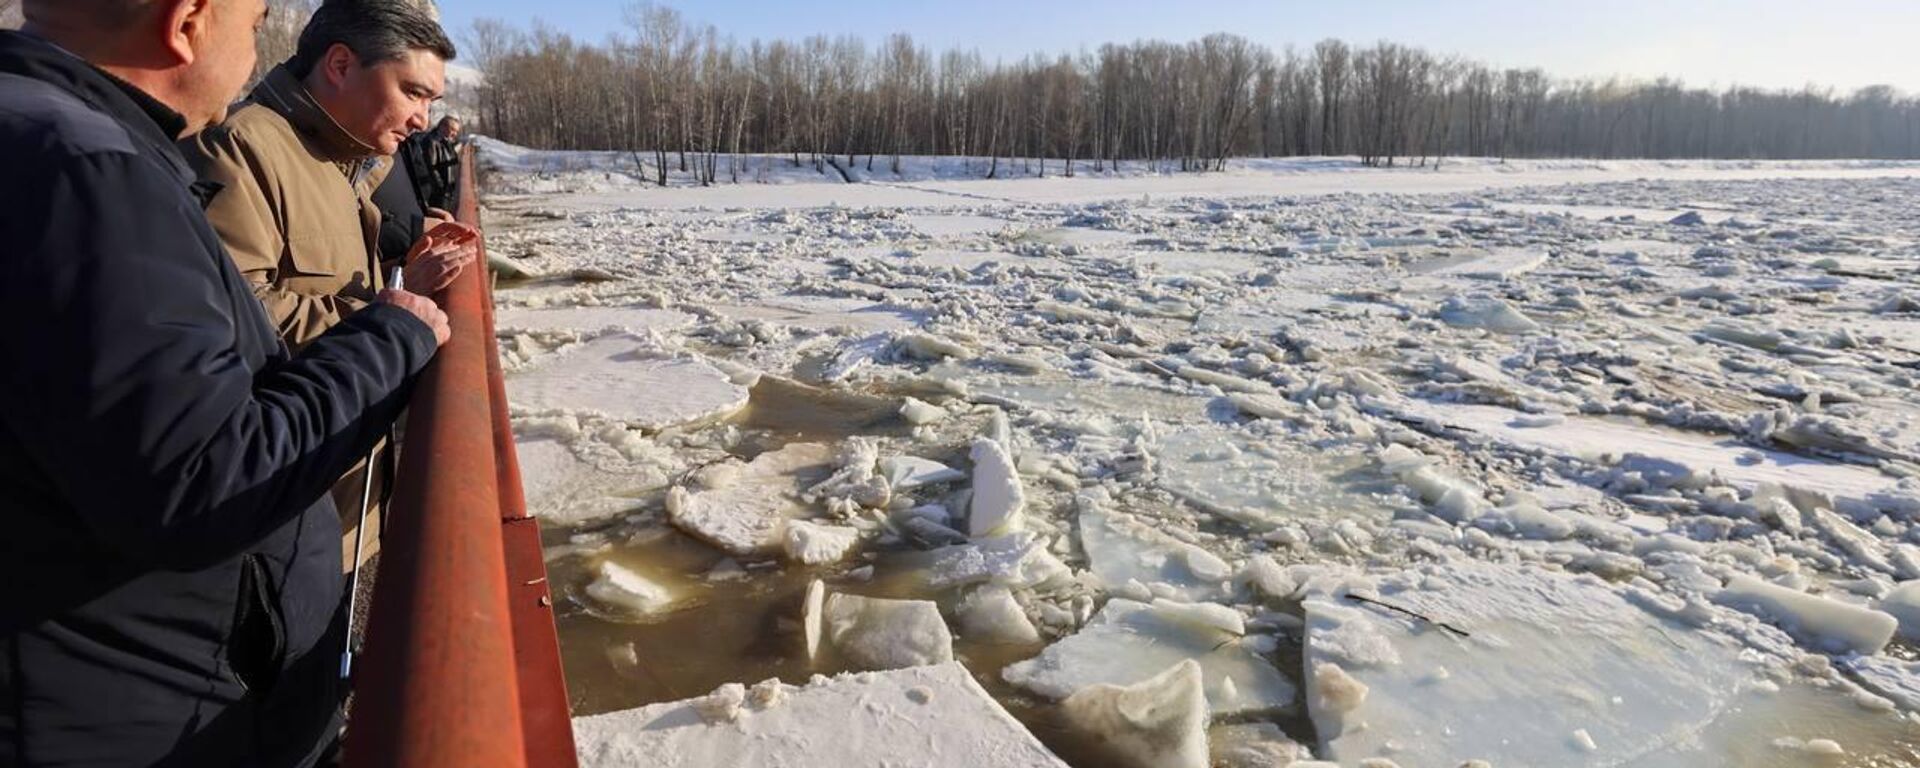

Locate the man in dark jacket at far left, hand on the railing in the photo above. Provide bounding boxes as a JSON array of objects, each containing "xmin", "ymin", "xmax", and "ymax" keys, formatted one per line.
[{"xmin": 0, "ymin": 0, "xmax": 447, "ymax": 766}]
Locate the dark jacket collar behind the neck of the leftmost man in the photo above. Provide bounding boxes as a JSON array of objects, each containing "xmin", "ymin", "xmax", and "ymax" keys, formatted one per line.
[{"xmin": 0, "ymin": 31, "xmax": 194, "ymax": 180}]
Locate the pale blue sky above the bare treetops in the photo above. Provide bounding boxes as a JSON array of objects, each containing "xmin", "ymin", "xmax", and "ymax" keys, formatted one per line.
[{"xmin": 440, "ymin": 0, "xmax": 1920, "ymax": 92}]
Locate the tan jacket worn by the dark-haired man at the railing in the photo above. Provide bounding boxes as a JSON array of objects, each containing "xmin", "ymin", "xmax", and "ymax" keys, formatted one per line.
[{"xmin": 182, "ymin": 65, "xmax": 394, "ymax": 349}]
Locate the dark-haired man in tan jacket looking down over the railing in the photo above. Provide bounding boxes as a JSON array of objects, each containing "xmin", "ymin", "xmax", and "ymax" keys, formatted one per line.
[{"xmin": 182, "ymin": 0, "xmax": 474, "ymax": 568}]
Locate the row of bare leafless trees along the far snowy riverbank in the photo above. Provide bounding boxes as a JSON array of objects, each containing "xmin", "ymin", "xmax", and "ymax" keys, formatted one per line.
[{"xmin": 41, "ymin": 0, "xmax": 1889, "ymax": 176}]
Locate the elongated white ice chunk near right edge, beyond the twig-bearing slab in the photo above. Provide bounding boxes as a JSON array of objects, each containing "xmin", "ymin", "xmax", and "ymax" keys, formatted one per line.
[{"xmin": 1713, "ymin": 576, "xmax": 1899, "ymax": 657}]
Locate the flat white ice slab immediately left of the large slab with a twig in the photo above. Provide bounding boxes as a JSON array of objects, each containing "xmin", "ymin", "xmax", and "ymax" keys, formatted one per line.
[{"xmin": 1000, "ymin": 597, "xmax": 1294, "ymax": 716}]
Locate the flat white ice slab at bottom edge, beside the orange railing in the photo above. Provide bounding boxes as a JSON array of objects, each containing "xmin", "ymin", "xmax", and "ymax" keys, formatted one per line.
[{"xmin": 574, "ymin": 662, "xmax": 1066, "ymax": 768}]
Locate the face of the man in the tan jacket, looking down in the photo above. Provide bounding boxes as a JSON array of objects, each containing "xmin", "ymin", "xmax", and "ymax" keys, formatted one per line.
[{"xmin": 328, "ymin": 50, "xmax": 447, "ymax": 156}]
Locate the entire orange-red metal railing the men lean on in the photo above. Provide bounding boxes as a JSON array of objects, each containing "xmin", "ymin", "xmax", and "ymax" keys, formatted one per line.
[{"xmin": 346, "ymin": 150, "xmax": 578, "ymax": 768}]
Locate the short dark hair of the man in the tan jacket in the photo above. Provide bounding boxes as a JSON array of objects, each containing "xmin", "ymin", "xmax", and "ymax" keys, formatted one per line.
[{"xmin": 286, "ymin": 0, "xmax": 455, "ymax": 77}]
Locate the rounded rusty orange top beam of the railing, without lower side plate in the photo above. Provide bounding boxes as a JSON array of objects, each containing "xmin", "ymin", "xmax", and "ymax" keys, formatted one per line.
[{"xmin": 346, "ymin": 149, "xmax": 529, "ymax": 768}]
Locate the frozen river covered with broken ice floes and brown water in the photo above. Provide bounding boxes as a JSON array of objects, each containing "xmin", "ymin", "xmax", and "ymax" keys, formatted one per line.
[{"xmin": 486, "ymin": 146, "xmax": 1920, "ymax": 768}]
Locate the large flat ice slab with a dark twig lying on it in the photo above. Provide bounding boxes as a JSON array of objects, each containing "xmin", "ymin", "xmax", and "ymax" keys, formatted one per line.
[{"xmin": 1306, "ymin": 561, "xmax": 1761, "ymax": 768}]
